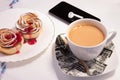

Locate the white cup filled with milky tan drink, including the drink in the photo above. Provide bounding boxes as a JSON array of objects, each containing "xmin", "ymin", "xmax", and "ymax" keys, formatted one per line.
[{"xmin": 66, "ymin": 18, "xmax": 116, "ymax": 60}]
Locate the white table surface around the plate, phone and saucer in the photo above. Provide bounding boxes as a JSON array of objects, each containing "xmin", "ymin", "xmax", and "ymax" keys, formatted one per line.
[{"xmin": 0, "ymin": 0, "xmax": 120, "ymax": 80}]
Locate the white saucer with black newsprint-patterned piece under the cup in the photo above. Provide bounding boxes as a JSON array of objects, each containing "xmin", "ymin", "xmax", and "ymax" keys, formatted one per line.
[{"xmin": 55, "ymin": 34, "xmax": 118, "ymax": 77}]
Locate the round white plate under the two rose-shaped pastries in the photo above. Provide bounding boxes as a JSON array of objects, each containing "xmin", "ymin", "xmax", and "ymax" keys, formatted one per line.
[{"xmin": 0, "ymin": 8, "xmax": 55, "ymax": 62}]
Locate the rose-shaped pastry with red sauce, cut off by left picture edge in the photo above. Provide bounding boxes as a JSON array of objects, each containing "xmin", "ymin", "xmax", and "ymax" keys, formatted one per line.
[{"xmin": 0, "ymin": 28, "xmax": 24, "ymax": 54}]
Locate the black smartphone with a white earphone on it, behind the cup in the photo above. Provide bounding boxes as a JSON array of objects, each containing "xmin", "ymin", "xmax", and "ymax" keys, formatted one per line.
[{"xmin": 49, "ymin": 1, "xmax": 101, "ymax": 23}]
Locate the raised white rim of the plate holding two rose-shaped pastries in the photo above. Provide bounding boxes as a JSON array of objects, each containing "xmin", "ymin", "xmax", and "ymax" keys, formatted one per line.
[{"xmin": 0, "ymin": 8, "xmax": 55, "ymax": 62}]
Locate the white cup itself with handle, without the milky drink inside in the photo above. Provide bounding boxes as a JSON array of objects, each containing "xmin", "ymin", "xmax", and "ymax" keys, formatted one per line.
[{"xmin": 66, "ymin": 19, "xmax": 116, "ymax": 60}]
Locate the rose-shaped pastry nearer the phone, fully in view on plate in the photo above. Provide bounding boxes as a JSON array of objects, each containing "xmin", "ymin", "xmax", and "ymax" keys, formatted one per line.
[{"xmin": 16, "ymin": 12, "xmax": 41, "ymax": 40}]
